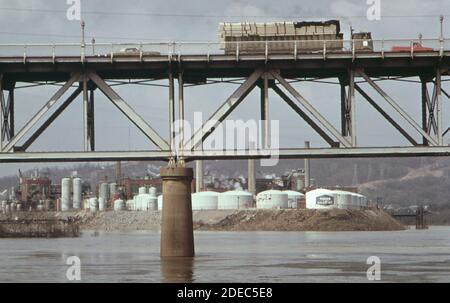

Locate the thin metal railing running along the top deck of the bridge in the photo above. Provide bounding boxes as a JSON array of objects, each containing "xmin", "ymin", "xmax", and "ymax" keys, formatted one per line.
[{"xmin": 0, "ymin": 39, "xmax": 444, "ymax": 60}]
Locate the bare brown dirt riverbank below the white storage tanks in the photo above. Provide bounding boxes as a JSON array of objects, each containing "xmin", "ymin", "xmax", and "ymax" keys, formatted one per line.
[{"xmin": 1, "ymin": 209, "xmax": 405, "ymax": 231}]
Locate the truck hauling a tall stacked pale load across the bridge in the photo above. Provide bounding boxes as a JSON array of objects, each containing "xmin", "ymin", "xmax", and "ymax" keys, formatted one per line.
[{"xmin": 219, "ymin": 20, "xmax": 373, "ymax": 55}]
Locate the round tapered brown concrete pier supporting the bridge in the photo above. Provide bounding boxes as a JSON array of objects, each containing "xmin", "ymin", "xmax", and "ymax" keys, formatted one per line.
[{"xmin": 160, "ymin": 167, "xmax": 195, "ymax": 257}]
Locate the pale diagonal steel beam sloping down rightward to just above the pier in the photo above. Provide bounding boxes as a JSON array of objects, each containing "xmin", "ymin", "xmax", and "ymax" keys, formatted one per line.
[{"xmin": 88, "ymin": 72, "xmax": 170, "ymax": 150}]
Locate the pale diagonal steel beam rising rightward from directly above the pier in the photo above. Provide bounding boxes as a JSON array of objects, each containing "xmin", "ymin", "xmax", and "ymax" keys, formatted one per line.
[{"xmin": 185, "ymin": 69, "xmax": 264, "ymax": 149}]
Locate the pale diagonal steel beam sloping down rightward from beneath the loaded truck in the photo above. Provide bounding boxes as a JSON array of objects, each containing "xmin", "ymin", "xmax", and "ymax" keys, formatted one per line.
[{"xmin": 271, "ymin": 72, "xmax": 352, "ymax": 147}]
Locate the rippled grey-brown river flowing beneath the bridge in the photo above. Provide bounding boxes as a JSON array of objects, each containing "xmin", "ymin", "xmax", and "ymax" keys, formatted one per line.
[{"xmin": 0, "ymin": 227, "xmax": 450, "ymax": 282}]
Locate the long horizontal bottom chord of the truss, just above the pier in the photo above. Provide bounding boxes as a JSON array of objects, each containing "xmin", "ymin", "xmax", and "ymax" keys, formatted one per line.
[{"xmin": 0, "ymin": 146, "xmax": 450, "ymax": 163}]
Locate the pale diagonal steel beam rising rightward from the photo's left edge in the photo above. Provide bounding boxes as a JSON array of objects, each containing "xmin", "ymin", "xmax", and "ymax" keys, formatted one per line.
[{"xmin": 3, "ymin": 73, "xmax": 81, "ymax": 152}]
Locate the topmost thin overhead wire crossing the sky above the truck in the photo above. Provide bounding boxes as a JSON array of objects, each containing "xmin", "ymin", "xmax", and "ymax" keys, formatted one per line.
[{"xmin": 0, "ymin": 7, "xmax": 450, "ymax": 19}]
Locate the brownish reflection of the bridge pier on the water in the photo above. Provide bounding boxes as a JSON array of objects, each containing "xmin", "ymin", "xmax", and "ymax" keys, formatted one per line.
[{"xmin": 161, "ymin": 257, "xmax": 194, "ymax": 283}]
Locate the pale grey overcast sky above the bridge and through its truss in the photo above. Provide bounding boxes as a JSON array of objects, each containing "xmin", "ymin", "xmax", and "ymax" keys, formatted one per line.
[{"xmin": 0, "ymin": 0, "xmax": 450, "ymax": 176}]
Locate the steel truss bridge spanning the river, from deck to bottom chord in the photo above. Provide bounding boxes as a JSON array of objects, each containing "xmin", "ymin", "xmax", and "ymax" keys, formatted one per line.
[{"xmin": 0, "ymin": 38, "xmax": 450, "ymax": 163}]
